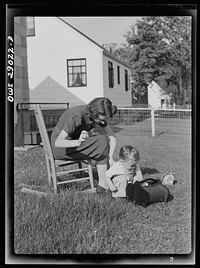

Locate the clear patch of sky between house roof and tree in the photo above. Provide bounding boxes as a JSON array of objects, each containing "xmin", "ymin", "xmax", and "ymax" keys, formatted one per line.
[{"xmin": 62, "ymin": 17, "xmax": 139, "ymax": 45}]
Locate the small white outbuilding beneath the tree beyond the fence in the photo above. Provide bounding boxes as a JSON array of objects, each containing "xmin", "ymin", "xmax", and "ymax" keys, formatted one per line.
[{"xmin": 148, "ymin": 81, "xmax": 171, "ymax": 109}]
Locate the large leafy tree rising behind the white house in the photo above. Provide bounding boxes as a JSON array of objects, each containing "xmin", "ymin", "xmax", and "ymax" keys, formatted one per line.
[{"xmin": 105, "ymin": 16, "xmax": 191, "ymax": 104}]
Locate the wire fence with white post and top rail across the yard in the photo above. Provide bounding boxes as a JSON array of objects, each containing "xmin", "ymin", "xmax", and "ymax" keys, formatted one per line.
[{"xmin": 110, "ymin": 108, "xmax": 192, "ymax": 138}]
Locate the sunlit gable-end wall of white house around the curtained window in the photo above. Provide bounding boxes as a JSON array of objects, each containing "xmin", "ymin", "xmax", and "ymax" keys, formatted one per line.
[{"xmin": 27, "ymin": 17, "xmax": 103, "ymax": 106}]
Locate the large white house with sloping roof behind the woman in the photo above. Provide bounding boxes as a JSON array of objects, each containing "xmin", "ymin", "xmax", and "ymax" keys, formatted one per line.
[{"xmin": 27, "ymin": 17, "xmax": 131, "ymax": 107}]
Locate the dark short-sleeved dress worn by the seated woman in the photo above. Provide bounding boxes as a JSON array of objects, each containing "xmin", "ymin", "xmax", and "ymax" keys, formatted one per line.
[{"xmin": 51, "ymin": 105, "xmax": 109, "ymax": 161}]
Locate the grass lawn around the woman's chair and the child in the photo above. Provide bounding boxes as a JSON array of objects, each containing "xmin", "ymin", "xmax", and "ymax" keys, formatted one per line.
[{"xmin": 14, "ymin": 127, "xmax": 191, "ymax": 254}]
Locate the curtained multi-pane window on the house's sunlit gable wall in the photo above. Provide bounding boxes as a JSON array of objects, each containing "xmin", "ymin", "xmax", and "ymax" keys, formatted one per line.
[{"xmin": 67, "ymin": 58, "xmax": 87, "ymax": 87}]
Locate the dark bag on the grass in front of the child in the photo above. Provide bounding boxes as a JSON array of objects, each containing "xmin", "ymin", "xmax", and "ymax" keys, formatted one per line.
[{"xmin": 126, "ymin": 178, "xmax": 169, "ymax": 207}]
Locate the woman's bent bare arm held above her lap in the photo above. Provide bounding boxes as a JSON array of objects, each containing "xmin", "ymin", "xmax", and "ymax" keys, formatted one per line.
[{"xmin": 55, "ymin": 130, "xmax": 88, "ymax": 148}]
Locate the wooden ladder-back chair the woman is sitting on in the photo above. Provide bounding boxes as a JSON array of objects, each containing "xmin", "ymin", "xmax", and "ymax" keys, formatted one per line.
[{"xmin": 34, "ymin": 104, "xmax": 94, "ymax": 192}]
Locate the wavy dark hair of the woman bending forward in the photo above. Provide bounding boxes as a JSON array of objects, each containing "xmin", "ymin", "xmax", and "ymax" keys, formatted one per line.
[{"xmin": 87, "ymin": 97, "xmax": 117, "ymax": 119}]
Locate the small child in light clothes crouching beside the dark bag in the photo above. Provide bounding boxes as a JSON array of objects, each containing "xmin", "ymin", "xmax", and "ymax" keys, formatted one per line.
[{"xmin": 106, "ymin": 145, "xmax": 143, "ymax": 197}]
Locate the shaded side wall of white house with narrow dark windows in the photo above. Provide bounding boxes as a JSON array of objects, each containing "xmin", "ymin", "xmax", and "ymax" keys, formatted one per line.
[{"xmin": 103, "ymin": 55, "xmax": 132, "ymax": 107}]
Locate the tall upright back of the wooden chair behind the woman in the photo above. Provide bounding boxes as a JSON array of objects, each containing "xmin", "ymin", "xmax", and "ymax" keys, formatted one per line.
[{"xmin": 34, "ymin": 104, "xmax": 53, "ymax": 158}]
